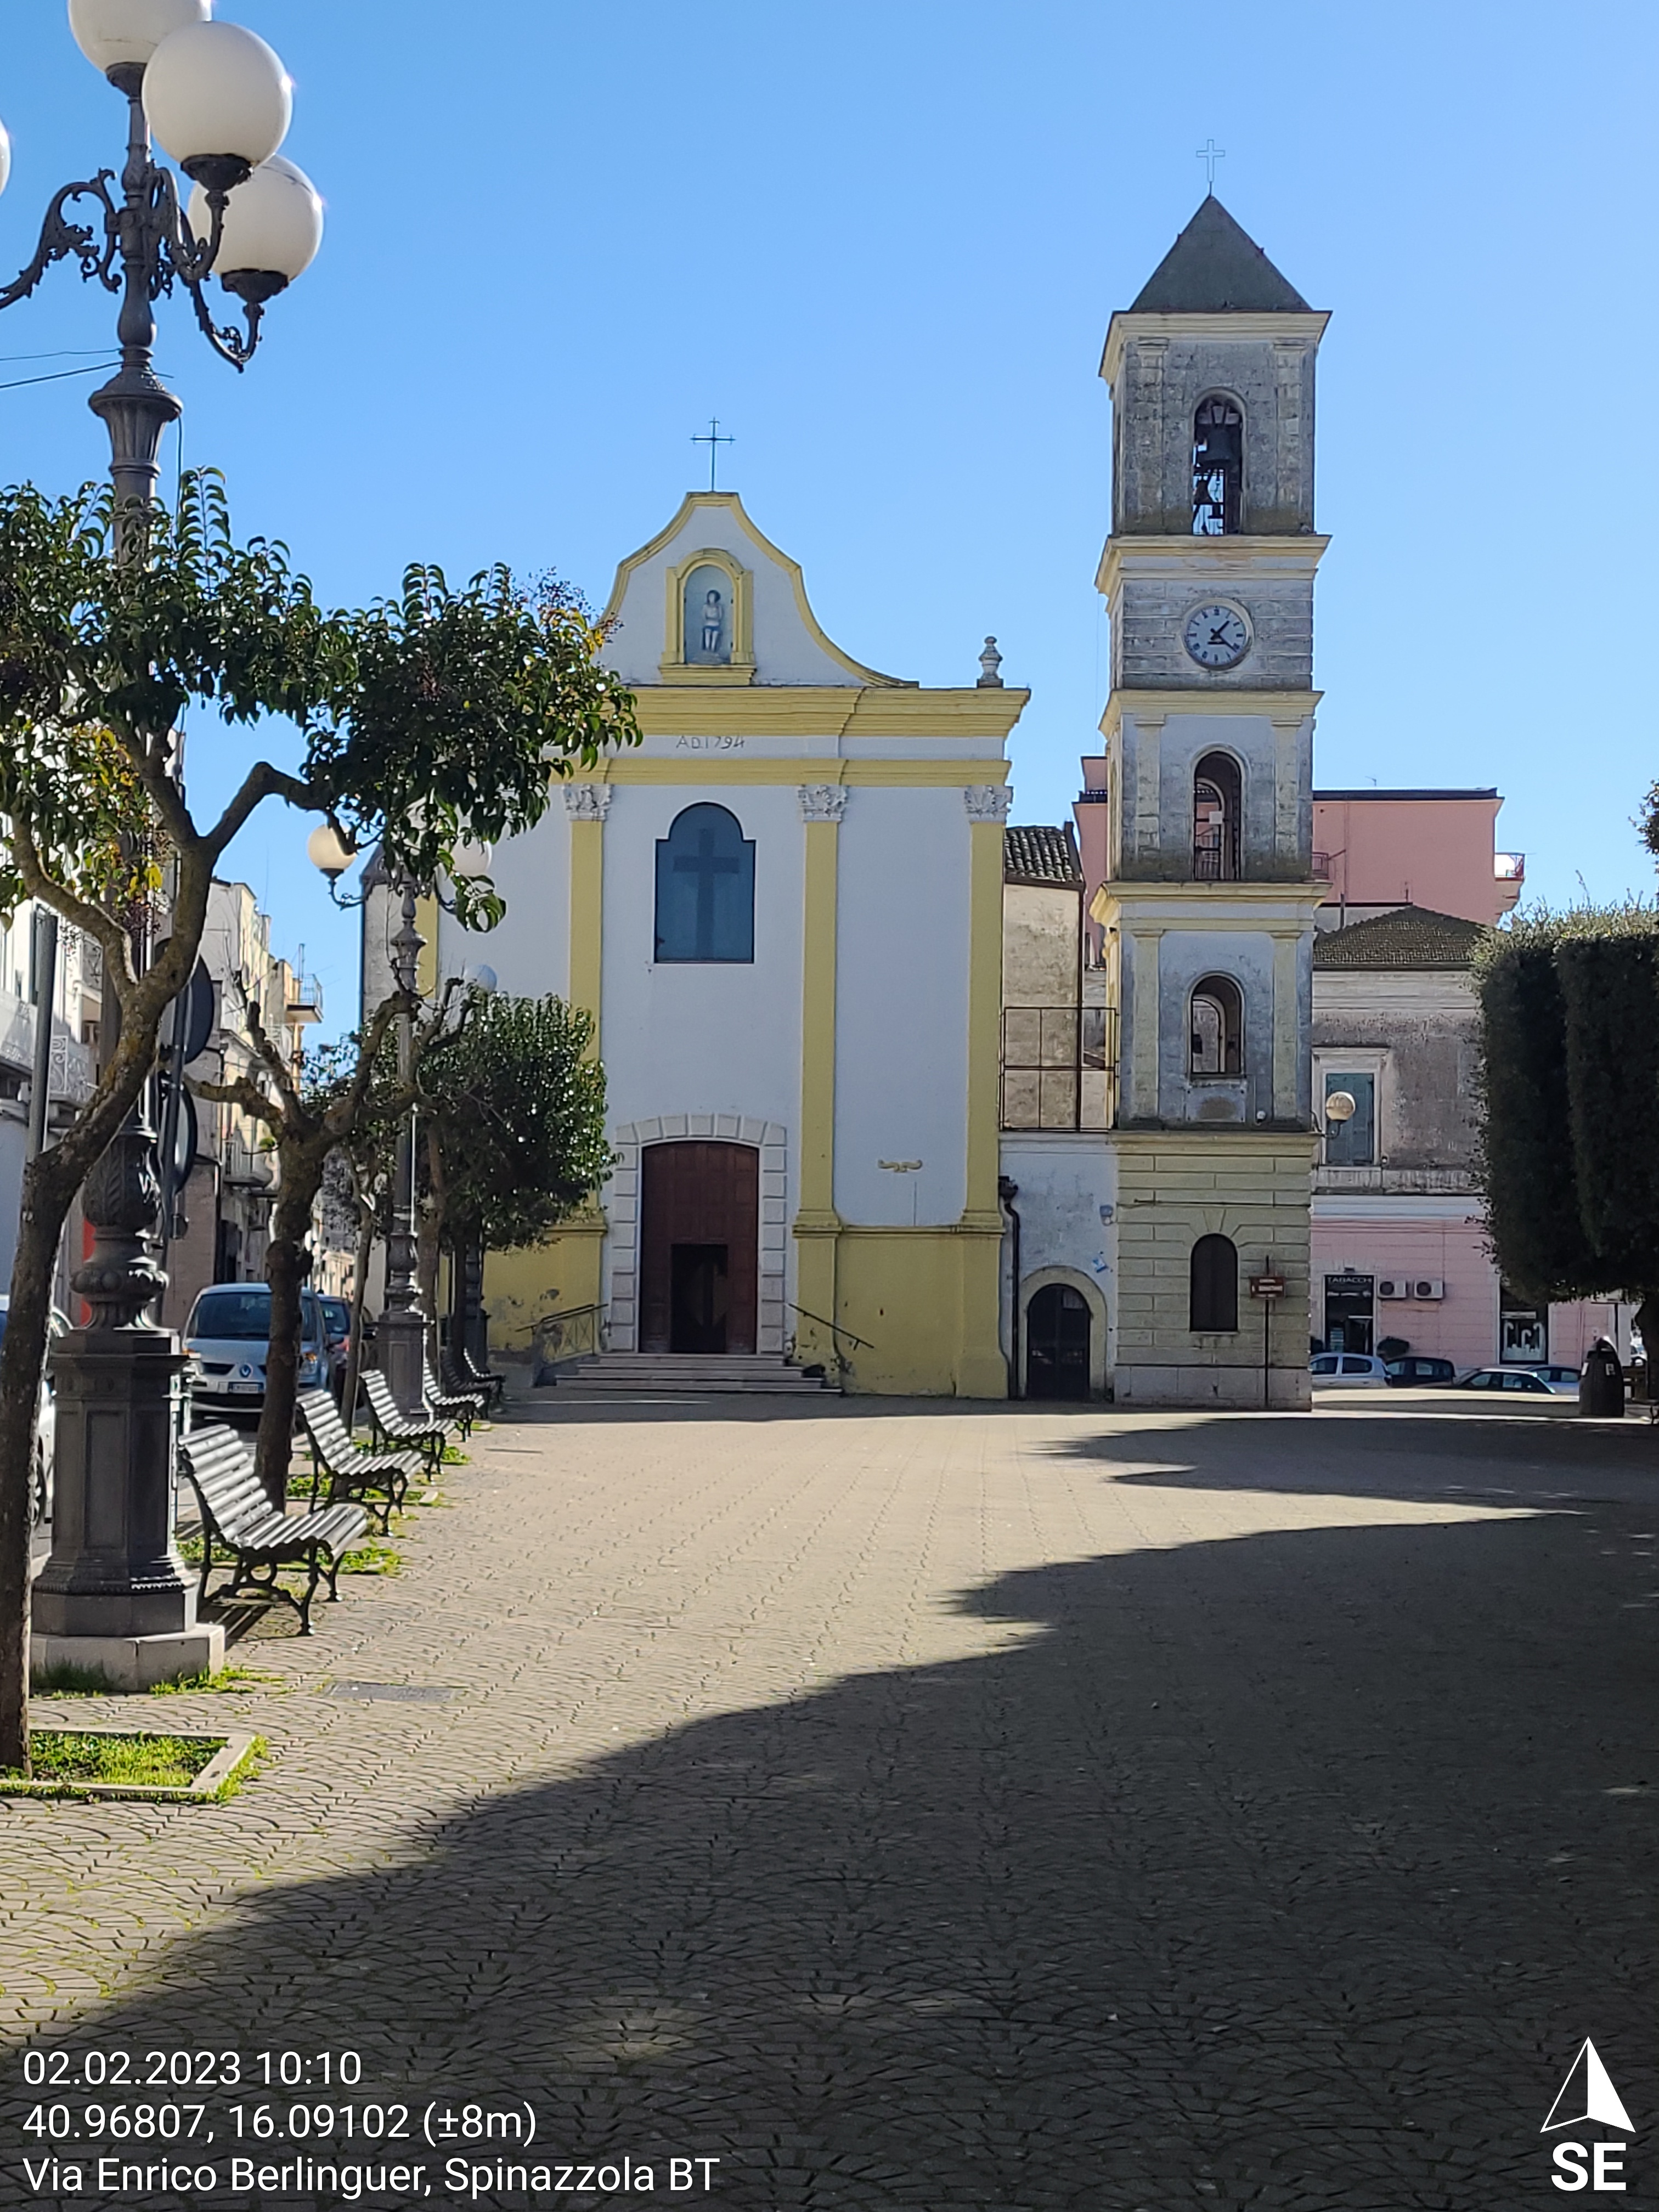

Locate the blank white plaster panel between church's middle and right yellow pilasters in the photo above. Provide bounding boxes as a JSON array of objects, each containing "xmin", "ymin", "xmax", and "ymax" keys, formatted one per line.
[{"xmin": 836, "ymin": 787, "xmax": 971, "ymax": 1226}]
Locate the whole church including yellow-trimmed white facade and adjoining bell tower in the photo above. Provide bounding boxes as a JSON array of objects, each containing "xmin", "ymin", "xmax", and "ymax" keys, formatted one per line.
[{"xmin": 427, "ymin": 199, "xmax": 1325, "ymax": 1407}]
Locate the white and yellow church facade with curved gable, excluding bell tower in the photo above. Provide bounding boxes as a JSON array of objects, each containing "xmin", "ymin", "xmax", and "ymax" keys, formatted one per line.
[{"xmin": 436, "ymin": 491, "xmax": 1026, "ymax": 1398}]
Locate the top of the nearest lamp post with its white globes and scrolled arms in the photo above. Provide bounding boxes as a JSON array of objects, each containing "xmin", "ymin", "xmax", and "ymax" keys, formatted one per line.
[{"xmin": 0, "ymin": 0, "xmax": 323, "ymax": 524}]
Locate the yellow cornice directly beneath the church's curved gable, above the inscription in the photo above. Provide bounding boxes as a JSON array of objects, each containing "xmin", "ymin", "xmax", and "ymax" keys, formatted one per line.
[{"xmin": 633, "ymin": 684, "xmax": 1031, "ymax": 739}]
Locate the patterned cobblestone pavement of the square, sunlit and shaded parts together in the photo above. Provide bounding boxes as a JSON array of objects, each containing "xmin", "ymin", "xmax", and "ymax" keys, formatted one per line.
[{"xmin": 0, "ymin": 1400, "xmax": 1659, "ymax": 2212}]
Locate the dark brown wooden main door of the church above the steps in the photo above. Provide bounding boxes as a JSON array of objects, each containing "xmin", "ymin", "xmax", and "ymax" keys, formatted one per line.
[{"xmin": 639, "ymin": 1139, "xmax": 761, "ymax": 1352}]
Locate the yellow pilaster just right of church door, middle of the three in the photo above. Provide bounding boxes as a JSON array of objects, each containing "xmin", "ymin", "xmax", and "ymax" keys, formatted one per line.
[{"xmin": 794, "ymin": 794, "xmax": 845, "ymax": 1367}]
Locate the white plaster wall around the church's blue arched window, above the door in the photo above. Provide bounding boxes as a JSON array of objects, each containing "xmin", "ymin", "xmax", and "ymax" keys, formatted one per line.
[{"xmin": 600, "ymin": 783, "xmax": 805, "ymax": 1159}]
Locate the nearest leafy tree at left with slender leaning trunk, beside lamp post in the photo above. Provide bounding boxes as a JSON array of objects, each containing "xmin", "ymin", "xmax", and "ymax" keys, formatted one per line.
[{"xmin": 0, "ymin": 473, "xmax": 637, "ymax": 1768}]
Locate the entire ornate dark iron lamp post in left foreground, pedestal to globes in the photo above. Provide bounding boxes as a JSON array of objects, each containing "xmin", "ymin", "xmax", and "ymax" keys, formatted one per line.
[{"xmin": 0, "ymin": 0, "xmax": 323, "ymax": 1688}]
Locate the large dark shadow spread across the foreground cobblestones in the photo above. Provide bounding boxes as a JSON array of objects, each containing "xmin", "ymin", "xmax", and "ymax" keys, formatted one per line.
[{"xmin": 16, "ymin": 1420, "xmax": 1659, "ymax": 2212}]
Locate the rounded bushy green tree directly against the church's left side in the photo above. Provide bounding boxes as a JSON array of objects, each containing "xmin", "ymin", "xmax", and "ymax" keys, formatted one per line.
[{"xmin": 416, "ymin": 995, "xmax": 615, "ymax": 1314}]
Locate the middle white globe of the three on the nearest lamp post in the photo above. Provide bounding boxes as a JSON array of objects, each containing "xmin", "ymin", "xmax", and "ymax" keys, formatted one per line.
[{"xmin": 144, "ymin": 22, "xmax": 294, "ymax": 193}]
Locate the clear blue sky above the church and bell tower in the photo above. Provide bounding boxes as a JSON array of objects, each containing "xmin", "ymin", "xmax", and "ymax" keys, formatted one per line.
[{"xmin": 0, "ymin": 0, "xmax": 1659, "ymax": 1026}]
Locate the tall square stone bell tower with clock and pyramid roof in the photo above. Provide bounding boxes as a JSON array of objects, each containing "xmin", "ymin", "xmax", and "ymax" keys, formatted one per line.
[{"xmin": 1093, "ymin": 195, "xmax": 1327, "ymax": 1404}]
